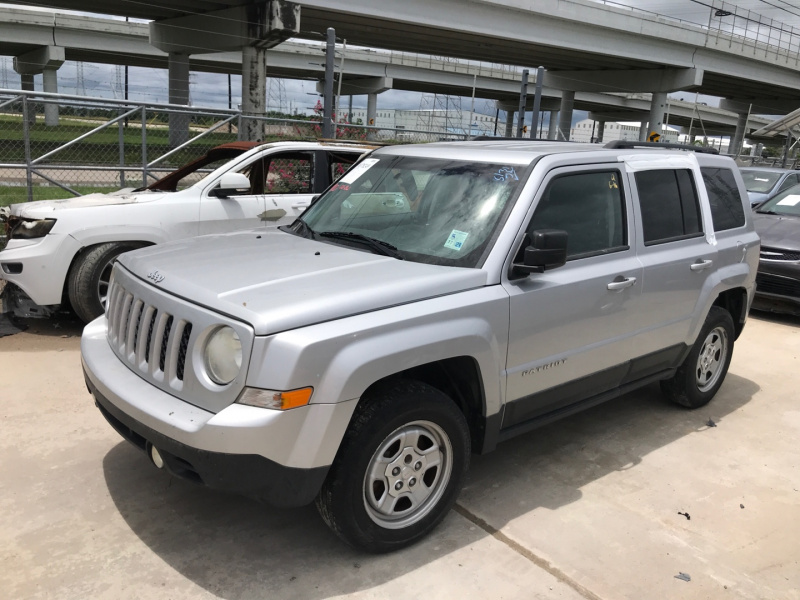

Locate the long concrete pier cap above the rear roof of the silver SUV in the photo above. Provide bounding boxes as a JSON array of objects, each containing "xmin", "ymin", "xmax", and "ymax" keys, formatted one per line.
[{"xmin": 544, "ymin": 68, "xmax": 703, "ymax": 92}]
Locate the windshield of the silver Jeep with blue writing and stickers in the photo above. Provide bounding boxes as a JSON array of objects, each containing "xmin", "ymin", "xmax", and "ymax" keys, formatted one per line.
[{"xmin": 295, "ymin": 156, "xmax": 525, "ymax": 267}]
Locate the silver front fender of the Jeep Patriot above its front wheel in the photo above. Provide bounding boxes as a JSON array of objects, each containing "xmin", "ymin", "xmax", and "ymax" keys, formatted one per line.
[{"xmin": 247, "ymin": 286, "xmax": 509, "ymax": 416}]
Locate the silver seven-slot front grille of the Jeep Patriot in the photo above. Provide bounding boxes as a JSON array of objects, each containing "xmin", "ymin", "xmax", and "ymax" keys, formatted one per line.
[{"xmin": 106, "ymin": 281, "xmax": 192, "ymax": 390}]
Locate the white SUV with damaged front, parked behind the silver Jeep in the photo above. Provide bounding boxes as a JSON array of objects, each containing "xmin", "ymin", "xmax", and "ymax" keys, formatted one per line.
[{"xmin": 0, "ymin": 142, "xmax": 369, "ymax": 322}]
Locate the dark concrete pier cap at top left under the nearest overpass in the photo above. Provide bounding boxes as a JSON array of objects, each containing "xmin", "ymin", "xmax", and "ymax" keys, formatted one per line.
[{"xmin": 150, "ymin": 0, "xmax": 300, "ymax": 54}]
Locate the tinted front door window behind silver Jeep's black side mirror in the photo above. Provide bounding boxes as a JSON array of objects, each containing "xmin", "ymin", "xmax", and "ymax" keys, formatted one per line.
[{"xmin": 527, "ymin": 170, "xmax": 628, "ymax": 260}]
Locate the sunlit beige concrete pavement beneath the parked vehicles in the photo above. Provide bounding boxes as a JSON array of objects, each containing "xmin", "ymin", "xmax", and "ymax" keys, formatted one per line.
[{"xmin": 0, "ymin": 316, "xmax": 800, "ymax": 599}]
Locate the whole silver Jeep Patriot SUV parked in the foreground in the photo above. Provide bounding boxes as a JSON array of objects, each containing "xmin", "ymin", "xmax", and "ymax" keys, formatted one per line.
[{"xmin": 82, "ymin": 140, "xmax": 759, "ymax": 552}]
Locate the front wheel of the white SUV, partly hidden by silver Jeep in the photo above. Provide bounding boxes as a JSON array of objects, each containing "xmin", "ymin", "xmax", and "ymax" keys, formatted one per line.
[{"xmin": 67, "ymin": 242, "xmax": 145, "ymax": 323}]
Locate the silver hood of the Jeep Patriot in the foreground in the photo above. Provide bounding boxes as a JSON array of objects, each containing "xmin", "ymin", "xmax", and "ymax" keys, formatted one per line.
[{"xmin": 120, "ymin": 230, "xmax": 486, "ymax": 335}]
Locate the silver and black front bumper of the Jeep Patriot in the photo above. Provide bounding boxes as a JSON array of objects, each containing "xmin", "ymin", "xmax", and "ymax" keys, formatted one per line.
[{"xmin": 81, "ymin": 317, "xmax": 357, "ymax": 506}]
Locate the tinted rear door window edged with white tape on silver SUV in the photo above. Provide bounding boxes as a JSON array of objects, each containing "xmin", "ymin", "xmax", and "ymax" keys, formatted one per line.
[{"xmin": 635, "ymin": 169, "xmax": 702, "ymax": 246}]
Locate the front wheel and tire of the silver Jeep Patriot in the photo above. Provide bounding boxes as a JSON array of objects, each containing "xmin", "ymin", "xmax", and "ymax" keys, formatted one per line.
[{"xmin": 316, "ymin": 380, "xmax": 470, "ymax": 552}]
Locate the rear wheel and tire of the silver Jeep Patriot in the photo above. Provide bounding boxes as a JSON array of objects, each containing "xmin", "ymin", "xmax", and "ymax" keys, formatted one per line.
[{"xmin": 661, "ymin": 306, "xmax": 734, "ymax": 408}]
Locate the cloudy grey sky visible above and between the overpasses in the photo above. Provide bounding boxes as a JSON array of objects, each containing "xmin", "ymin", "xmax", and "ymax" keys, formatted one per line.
[{"xmin": 0, "ymin": 0, "xmax": 800, "ymax": 121}]
